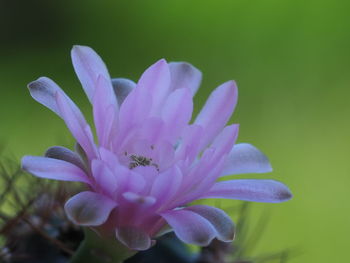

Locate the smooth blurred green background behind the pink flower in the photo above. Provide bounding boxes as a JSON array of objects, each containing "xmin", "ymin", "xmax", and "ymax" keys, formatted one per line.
[{"xmin": 0, "ymin": 0, "xmax": 350, "ymax": 263}]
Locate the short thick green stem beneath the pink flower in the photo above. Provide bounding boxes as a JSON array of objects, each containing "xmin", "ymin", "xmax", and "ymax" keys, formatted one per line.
[{"xmin": 70, "ymin": 228, "xmax": 135, "ymax": 263}]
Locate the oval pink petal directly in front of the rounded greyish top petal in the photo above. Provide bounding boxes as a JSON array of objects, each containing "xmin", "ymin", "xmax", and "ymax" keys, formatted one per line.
[{"xmin": 162, "ymin": 88, "xmax": 193, "ymax": 143}]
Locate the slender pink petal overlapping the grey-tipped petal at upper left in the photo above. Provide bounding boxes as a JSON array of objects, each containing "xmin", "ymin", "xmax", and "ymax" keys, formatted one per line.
[{"xmin": 56, "ymin": 92, "xmax": 97, "ymax": 160}]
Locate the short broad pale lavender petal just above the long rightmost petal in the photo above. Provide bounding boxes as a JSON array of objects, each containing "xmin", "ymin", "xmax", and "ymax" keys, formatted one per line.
[{"xmin": 222, "ymin": 143, "xmax": 272, "ymax": 175}]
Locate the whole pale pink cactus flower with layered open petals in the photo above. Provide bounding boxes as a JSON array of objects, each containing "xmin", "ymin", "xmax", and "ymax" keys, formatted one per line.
[{"xmin": 22, "ymin": 46, "xmax": 292, "ymax": 250}]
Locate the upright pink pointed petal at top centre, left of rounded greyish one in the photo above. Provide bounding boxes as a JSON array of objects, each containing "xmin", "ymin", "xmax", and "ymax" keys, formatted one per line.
[{"xmin": 136, "ymin": 59, "xmax": 170, "ymax": 115}]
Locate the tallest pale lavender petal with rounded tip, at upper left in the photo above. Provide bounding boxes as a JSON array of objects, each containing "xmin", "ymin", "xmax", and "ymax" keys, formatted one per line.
[{"xmin": 71, "ymin": 46, "xmax": 113, "ymax": 102}]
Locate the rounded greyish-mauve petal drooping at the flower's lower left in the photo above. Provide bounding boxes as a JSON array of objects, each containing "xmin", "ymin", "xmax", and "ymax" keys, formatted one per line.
[{"xmin": 64, "ymin": 191, "xmax": 117, "ymax": 226}]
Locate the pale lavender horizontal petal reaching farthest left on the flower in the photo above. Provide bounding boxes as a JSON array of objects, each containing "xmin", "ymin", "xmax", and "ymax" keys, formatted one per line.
[{"xmin": 22, "ymin": 156, "xmax": 90, "ymax": 183}]
